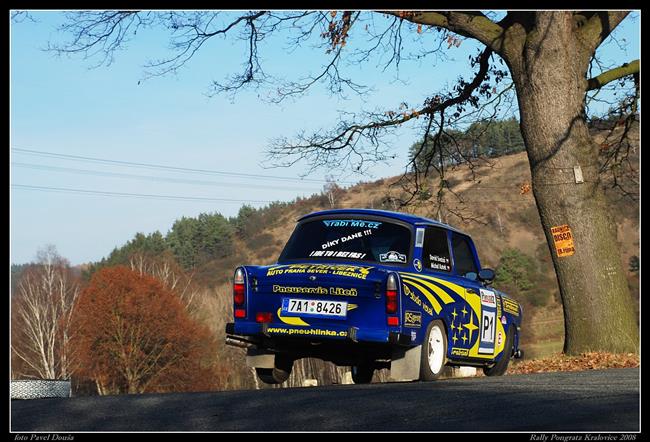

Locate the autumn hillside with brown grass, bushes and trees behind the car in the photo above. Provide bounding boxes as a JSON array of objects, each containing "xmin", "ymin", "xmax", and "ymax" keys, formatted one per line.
[{"xmin": 12, "ymin": 121, "xmax": 640, "ymax": 394}]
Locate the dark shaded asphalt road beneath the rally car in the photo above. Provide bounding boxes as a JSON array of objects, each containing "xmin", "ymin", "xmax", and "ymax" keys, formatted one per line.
[{"xmin": 11, "ymin": 369, "xmax": 640, "ymax": 432}]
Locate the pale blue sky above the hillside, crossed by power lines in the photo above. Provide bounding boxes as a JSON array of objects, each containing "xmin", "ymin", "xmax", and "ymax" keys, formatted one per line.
[{"xmin": 10, "ymin": 11, "xmax": 640, "ymax": 264}]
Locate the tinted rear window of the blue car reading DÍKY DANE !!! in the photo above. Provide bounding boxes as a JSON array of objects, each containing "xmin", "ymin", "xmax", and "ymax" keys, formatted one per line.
[{"xmin": 279, "ymin": 217, "xmax": 411, "ymax": 265}]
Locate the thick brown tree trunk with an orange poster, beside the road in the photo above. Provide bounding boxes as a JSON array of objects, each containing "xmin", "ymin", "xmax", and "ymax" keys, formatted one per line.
[{"xmin": 508, "ymin": 11, "xmax": 639, "ymax": 354}]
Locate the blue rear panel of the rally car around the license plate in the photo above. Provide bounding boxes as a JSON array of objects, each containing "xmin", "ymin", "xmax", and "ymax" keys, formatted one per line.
[{"xmin": 230, "ymin": 263, "xmax": 399, "ymax": 342}]
